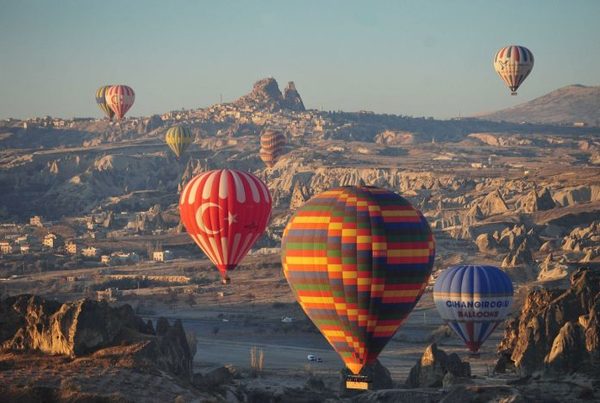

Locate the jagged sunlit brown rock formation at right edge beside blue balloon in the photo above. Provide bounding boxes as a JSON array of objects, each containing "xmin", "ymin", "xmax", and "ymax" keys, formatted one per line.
[{"xmin": 498, "ymin": 268, "xmax": 600, "ymax": 375}]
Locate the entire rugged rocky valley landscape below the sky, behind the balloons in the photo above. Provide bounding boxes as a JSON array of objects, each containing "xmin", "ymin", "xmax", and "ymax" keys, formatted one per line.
[{"xmin": 0, "ymin": 79, "xmax": 600, "ymax": 402}]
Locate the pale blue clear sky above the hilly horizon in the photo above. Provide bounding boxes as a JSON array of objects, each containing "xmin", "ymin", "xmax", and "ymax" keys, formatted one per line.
[{"xmin": 0, "ymin": 0, "xmax": 600, "ymax": 118}]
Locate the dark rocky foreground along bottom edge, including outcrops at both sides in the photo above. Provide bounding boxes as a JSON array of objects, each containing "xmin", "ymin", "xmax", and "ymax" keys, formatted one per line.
[{"xmin": 0, "ymin": 269, "xmax": 600, "ymax": 402}]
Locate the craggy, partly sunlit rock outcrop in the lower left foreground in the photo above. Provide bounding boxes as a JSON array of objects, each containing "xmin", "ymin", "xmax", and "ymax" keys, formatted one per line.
[{"xmin": 0, "ymin": 295, "xmax": 193, "ymax": 379}]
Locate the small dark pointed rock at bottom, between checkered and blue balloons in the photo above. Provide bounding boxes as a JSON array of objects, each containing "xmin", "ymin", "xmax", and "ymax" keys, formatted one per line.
[{"xmin": 405, "ymin": 343, "xmax": 471, "ymax": 388}]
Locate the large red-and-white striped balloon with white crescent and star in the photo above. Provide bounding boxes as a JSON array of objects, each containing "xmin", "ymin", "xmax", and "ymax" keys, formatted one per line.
[{"xmin": 179, "ymin": 169, "xmax": 271, "ymax": 283}]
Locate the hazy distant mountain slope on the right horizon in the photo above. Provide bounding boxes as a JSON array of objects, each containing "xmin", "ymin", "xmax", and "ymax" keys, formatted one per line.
[{"xmin": 477, "ymin": 85, "xmax": 600, "ymax": 126}]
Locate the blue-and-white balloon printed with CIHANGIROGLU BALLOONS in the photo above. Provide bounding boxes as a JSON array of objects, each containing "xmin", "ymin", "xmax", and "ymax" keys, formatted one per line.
[{"xmin": 433, "ymin": 266, "xmax": 513, "ymax": 353}]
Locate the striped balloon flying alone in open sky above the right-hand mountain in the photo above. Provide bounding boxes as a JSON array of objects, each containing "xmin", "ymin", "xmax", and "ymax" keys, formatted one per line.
[{"xmin": 494, "ymin": 45, "xmax": 533, "ymax": 95}]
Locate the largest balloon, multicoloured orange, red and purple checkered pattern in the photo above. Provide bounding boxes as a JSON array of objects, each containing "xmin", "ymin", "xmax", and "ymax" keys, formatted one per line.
[{"xmin": 281, "ymin": 186, "xmax": 435, "ymax": 385}]
